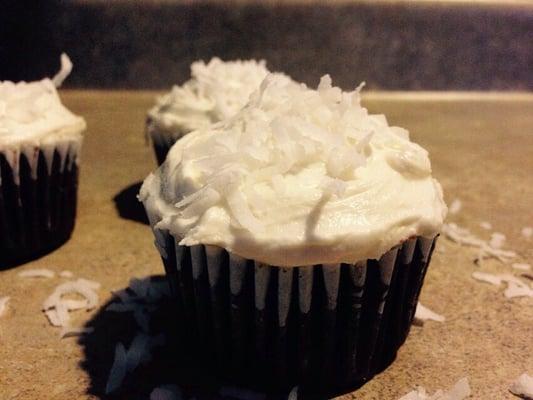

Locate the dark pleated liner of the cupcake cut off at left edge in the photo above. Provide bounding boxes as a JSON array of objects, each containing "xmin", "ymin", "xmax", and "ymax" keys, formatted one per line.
[{"xmin": 0, "ymin": 148, "xmax": 78, "ymax": 269}]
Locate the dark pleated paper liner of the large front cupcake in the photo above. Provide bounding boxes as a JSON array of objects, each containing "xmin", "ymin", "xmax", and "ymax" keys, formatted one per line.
[{"xmin": 147, "ymin": 225, "xmax": 435, "ymax": 395}]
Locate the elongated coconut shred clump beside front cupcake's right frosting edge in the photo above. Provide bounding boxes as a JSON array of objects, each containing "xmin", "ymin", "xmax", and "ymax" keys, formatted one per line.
[{"xmin": 442, "ymin": 222, "xmax": 517, "ymax": 264}]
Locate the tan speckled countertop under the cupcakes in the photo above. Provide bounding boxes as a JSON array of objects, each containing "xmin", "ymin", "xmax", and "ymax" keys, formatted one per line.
[{"xmin": 0, "ymin": 91, "xmax": 533, "ymax": 400}]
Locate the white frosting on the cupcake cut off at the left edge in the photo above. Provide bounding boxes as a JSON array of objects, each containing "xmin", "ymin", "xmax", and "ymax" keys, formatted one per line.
[{"xmin": 0, "ymin": 54, "xmax": 86, "ymax": 181}]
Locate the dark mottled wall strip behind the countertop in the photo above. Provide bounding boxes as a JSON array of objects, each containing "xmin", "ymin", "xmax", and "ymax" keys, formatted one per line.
[{"xmin": 0, "ymin": 0, "xmax": 533, "ymax": 91}]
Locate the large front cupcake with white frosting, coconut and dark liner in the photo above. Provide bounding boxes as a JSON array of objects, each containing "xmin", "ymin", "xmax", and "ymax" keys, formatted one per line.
[{"xmin": 139, "ymin": 75, "xmax": 447, "ymax": 394}]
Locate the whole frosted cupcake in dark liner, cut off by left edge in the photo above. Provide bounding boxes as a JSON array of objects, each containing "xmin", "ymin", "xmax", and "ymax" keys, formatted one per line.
[{"xmin": 0, "ymin": 54, "xmax": 85, "ymax": 266}]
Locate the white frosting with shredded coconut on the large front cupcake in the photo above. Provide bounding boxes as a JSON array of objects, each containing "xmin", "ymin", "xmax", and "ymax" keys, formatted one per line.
[{"xmin": 140, "ymin": 75, "xmax": 447, "ymax": 266}]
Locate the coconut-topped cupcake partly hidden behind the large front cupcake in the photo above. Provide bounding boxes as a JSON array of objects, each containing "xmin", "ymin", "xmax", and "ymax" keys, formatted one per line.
[{"xmin": 146, "ymin": 57, "xmax": 289, "ymax": 164}]
